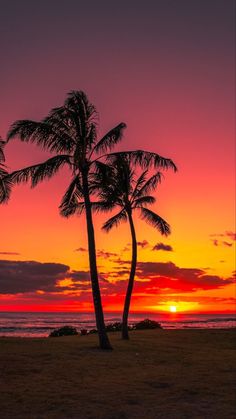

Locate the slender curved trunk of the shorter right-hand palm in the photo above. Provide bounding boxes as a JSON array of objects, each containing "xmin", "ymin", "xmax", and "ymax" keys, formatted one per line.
[{"xmin": 122, "ymin": 212, "xmax": 137, "ymax": 340}]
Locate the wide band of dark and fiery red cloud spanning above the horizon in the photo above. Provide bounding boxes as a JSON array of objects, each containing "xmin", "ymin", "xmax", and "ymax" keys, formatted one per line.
[{"xmin": 0, "ymin": 259, "xmax": 235, "ymax": 304}]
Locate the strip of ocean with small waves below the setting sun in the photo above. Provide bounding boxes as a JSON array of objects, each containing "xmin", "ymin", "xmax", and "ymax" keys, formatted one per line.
[{"xmin": 0, "ymin": 312, "xmax": 236, "ymax": 337}]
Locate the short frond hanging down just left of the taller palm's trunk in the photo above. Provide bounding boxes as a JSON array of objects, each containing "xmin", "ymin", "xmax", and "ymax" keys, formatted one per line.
[{"xmin": 59, "ymin": 175, "xmax": 84, "ymax": 217}]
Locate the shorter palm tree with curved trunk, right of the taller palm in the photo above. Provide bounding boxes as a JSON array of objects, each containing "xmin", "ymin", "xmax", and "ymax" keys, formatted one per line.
[{"xmin": 96, "ymin": 155, "xmax": 170, "ymax": 339}]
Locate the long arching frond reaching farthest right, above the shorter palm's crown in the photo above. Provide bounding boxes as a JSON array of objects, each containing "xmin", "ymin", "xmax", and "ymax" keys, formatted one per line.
[{"xmin": 107, "ymin": 150, "xmax": 177, "ymax": 172}]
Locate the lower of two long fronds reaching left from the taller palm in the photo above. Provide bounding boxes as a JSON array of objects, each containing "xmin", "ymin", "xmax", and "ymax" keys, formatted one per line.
[{"xmin": 9, "ymin": 155, "xmax": 71, "ymax": 187}]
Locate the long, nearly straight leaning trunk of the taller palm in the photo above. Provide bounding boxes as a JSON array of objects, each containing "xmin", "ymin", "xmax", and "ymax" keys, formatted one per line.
[{"xmin": 82, "ymin": 173, "xmax": 112, "ymax": 349}]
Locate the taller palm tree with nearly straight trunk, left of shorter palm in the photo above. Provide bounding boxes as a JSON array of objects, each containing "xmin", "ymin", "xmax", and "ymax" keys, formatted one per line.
[{"xmin": 7, "ymin": 91, "xmax": 128, "ymax": 349}]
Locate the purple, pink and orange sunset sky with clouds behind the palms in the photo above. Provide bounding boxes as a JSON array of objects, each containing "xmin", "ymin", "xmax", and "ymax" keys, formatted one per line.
[{"xmin": 0, "ymin": 0, "xmax": 235, "ymax": 313}]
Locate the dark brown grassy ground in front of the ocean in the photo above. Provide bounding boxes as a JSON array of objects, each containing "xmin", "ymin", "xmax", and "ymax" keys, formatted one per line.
[{"xmin": 0, "ymin": 329, "xmax": 236, "ymax": 419}]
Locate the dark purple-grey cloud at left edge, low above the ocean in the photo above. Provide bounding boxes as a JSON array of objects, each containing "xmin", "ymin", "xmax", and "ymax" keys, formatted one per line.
[{"xmin": 0, "ymin": 260, "xmax": 69, "ymax": 294}]
